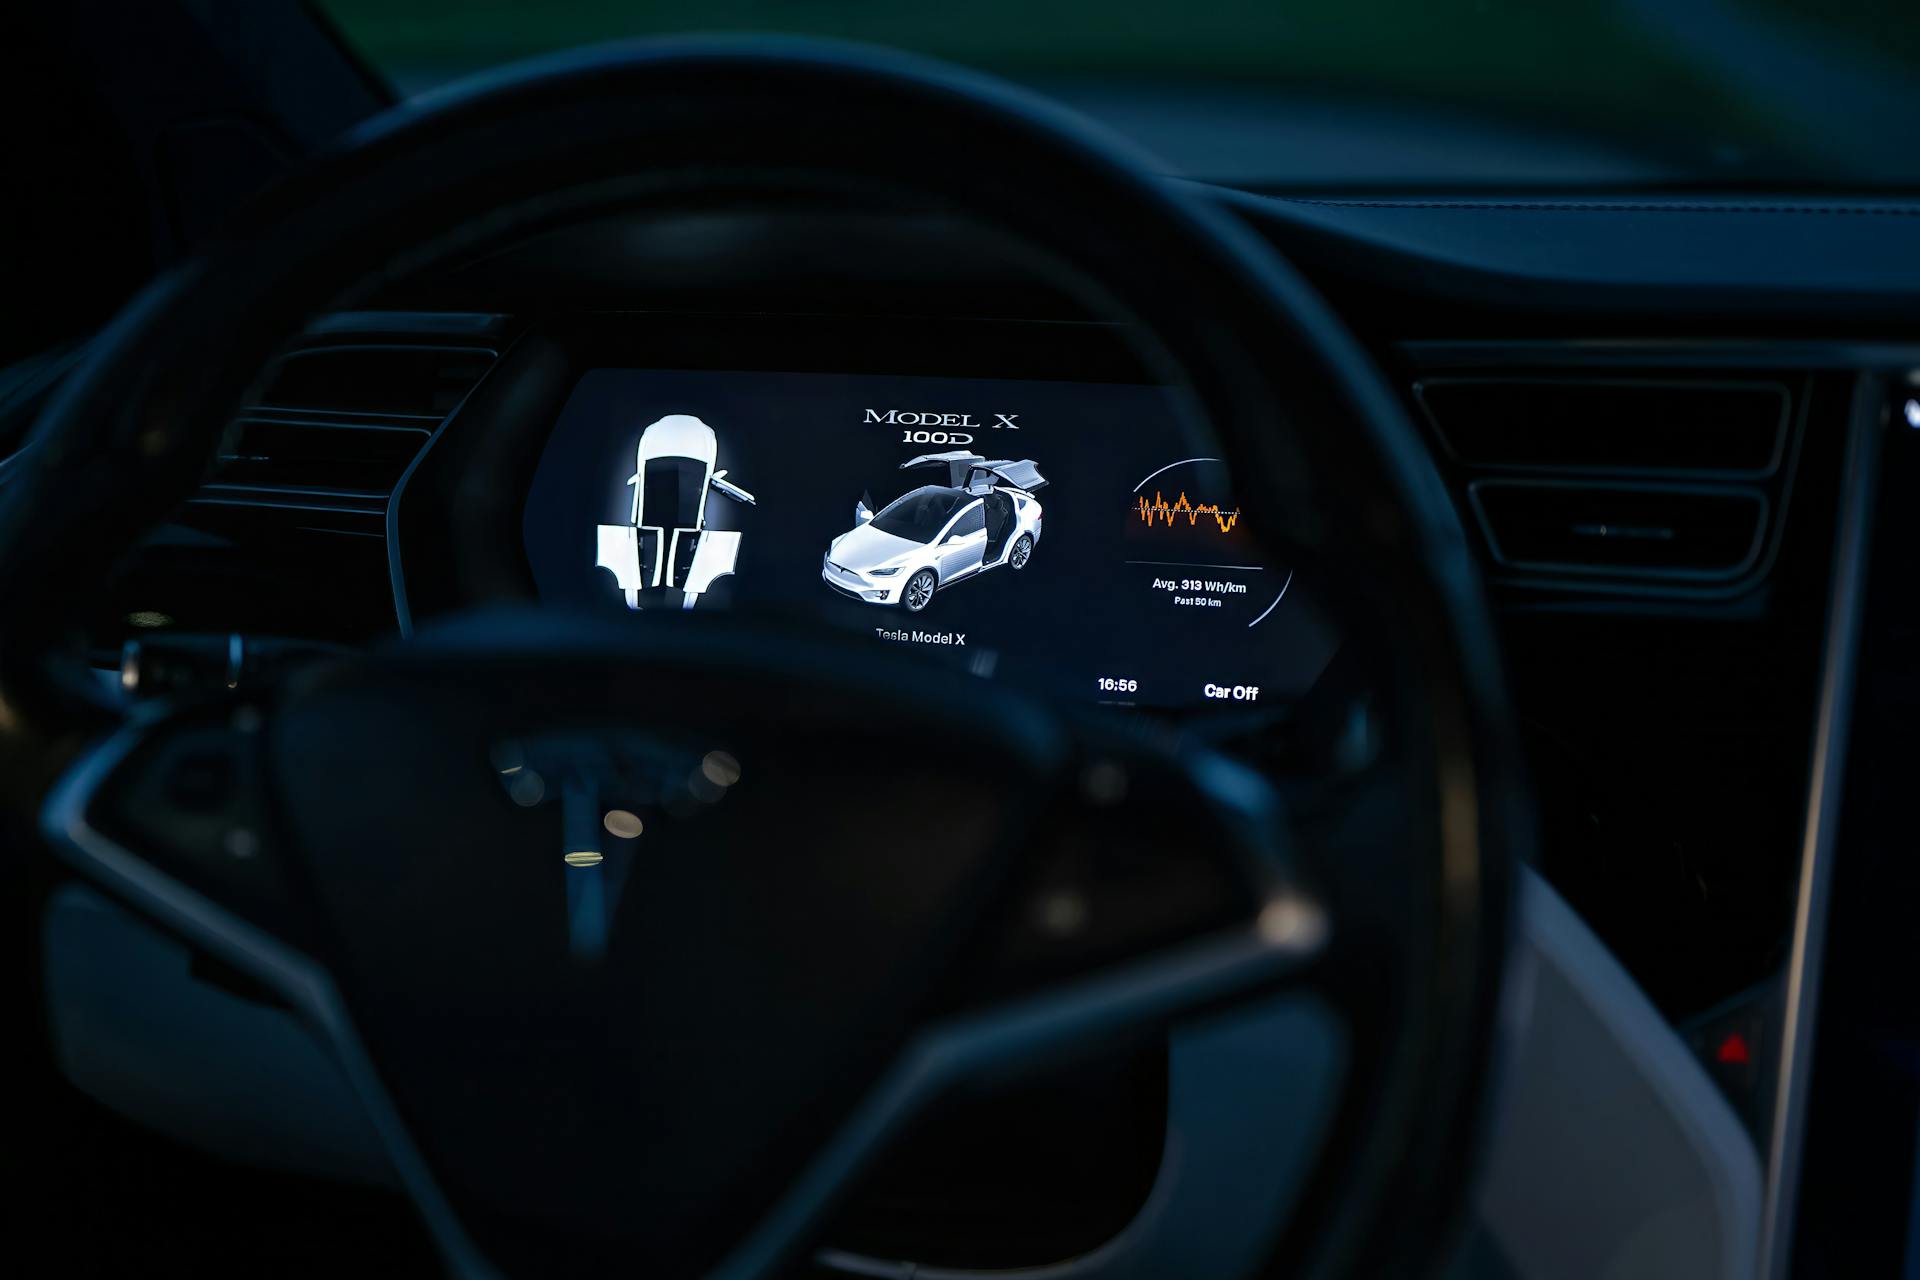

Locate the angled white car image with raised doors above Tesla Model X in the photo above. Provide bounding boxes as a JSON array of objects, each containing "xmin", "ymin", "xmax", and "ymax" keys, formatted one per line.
[{"xmin": 820, "ymin": 451, "xmax": 1046, "ymax": 614}]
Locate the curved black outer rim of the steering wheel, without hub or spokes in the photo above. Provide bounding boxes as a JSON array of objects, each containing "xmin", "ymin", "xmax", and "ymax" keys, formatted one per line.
[{"xmin": 0, "ymin": 42, "xmax": 1526, "ymax": 1268}]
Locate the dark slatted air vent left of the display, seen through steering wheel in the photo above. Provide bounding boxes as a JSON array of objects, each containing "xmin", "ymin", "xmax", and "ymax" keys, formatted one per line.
[{"xmin": 96, "ymin": 313, "xmax": 505, "ymax": 645}]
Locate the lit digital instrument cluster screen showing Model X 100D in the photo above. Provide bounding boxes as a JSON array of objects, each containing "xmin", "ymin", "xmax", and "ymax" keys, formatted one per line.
[{"xmin": 522, "ymin": 368, "xmax": 1334, "ymax": 708}]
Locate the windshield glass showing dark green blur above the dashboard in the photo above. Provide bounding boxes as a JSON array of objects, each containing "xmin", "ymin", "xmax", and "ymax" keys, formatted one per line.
[{"xmin": 321, "ymin": 0, "xmax": 1920, "ymax": 190}]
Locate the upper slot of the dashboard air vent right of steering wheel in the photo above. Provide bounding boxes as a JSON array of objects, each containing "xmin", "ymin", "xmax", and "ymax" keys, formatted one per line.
[{"xmin": 1413, "ymin": 378, "xmax": 1791, "ymax": 478}]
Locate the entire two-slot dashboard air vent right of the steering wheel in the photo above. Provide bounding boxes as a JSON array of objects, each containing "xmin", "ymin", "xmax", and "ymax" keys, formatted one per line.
[{"xmin": 1413, "ymin": 370, "xmax": 1799, "ymax": 595}]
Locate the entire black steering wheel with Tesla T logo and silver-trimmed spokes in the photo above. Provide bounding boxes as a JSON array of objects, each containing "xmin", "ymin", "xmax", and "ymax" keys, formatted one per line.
[{"xmin": 0, "ymin": 42, "xmax": 1526, "ymax": 1276}]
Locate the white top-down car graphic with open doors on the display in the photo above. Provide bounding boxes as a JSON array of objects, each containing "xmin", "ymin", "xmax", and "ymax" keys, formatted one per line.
[{"xmin": 595, "ymin": 413, "xmax": 753, "ymax": 608}]
